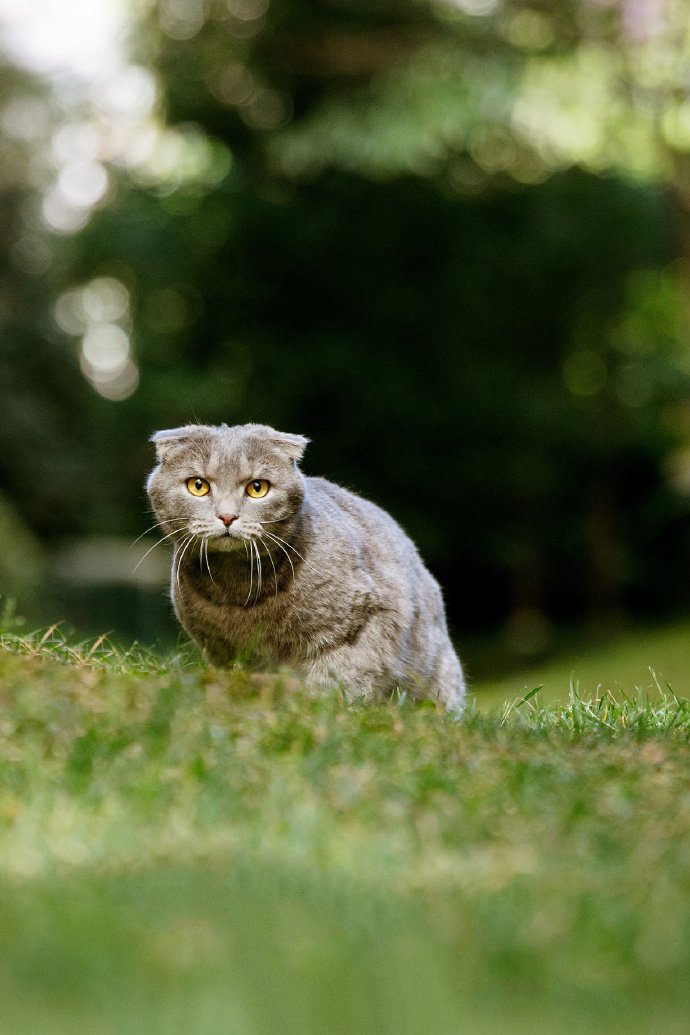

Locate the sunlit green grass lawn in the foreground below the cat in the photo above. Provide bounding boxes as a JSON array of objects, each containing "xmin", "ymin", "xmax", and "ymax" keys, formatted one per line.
[{"xmin": 0, "ymin": 616, "xmax": 690, "ymax": 1035}]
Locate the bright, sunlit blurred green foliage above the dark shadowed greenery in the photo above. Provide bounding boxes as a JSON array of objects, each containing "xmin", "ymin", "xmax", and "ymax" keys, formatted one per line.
[{"xmin": 148, "ymin": 0, "xmax": 689, "ymax": 191}]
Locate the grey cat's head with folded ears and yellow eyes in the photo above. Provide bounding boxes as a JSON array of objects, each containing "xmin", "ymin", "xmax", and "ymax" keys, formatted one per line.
[{"xmin": 146, "ymin": 424, "xmax": 308, "ymax": 551}]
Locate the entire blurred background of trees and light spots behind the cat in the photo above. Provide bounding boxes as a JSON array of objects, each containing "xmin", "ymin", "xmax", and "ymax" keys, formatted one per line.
[{"xmin": 0, "ymin": 0, "xmax": 690, "ymax": 674}]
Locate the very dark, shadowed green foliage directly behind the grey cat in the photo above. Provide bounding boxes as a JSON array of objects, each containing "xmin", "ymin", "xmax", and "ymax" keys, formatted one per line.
[{"xmin": 40, "ymin": 165, "xmax": 688, "ymax": 627}]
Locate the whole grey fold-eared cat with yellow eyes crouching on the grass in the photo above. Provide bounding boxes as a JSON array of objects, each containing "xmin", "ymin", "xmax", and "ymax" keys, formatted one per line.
[{"xmin": 147, "ymin": 424, "xmax": 464, "ymax": 711}]
